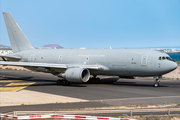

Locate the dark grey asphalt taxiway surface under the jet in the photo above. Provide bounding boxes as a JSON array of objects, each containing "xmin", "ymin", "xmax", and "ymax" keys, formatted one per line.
[{"xmin": 0, "ymin": 70, "xmax": 180, "ymax": 113}]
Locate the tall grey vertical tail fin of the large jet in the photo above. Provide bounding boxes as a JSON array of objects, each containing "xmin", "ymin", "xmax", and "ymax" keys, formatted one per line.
[{"xmin": 3, "ymin": 12, "xmax": 35, "ymax": 53}]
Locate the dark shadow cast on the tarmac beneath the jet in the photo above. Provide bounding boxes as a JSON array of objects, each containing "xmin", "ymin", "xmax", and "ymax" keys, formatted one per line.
[{"xmin": 1, "ymin": 77, "xmax": 169, "ymax": 87}]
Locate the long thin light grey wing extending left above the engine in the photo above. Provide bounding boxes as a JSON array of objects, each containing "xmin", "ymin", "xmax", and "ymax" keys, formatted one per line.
[{"xmin": 0, "ymin": 61, "xmax": 106, "ymax": 70}]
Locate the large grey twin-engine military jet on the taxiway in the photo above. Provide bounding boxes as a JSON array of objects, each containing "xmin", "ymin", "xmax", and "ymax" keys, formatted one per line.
[{"xmin": 0, "ymin": 12, "xmax": 177, "ymax": 87}]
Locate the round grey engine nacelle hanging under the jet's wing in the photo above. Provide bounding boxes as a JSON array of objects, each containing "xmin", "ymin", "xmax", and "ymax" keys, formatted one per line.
[{"xmin": 59, "ymin": 68, "xmax": 90, "ymax": 82}]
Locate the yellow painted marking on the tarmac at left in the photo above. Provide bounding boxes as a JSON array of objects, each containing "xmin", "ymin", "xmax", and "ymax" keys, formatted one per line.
[{"xmin": 0, "ymin": 82, "xmax": 36, "ymax": 92}]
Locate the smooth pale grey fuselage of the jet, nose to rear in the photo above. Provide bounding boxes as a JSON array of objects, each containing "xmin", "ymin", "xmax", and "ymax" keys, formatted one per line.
[{"xmin": 11, "ymin": 49, "xmax": 177, "ymax": 76}]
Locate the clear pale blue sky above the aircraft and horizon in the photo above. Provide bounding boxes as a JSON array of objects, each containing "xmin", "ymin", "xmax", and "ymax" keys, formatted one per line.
[{"xmin": 0, "ymin": 0, "xmax": 180, "ymax": 48}]
